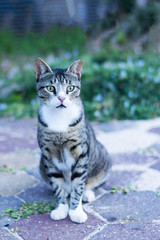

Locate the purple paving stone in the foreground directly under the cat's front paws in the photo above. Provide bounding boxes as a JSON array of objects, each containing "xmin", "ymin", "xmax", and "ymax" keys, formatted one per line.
[{"xmin": 9, "ymin": 214, "xmax": 104, "ymax": 240}]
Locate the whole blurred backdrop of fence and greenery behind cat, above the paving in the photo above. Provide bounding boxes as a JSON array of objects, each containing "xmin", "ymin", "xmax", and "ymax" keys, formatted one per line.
[{"xmin": 0, "ymin": 0, "xmax": 160, "ymax": 122}]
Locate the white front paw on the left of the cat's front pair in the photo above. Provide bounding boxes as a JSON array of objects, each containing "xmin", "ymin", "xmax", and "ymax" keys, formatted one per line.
[{"xmin": 50, "ymin": 203, "xmax": 69, "ymax": 220}]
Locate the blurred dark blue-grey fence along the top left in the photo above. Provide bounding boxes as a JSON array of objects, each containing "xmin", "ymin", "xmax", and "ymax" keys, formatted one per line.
[{"xmin": 0, "ymin": 0, "xmax": 114, "ymax": 33}]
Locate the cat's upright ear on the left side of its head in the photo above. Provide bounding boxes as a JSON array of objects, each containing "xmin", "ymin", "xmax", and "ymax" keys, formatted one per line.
[{"xmin": 34, "ymin": 58, "xmax": 52, "ymax": 82}]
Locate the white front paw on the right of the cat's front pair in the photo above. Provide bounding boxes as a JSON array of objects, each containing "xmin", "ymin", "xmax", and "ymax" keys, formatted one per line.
[{"xmin": 69, "ymin": 208, "xmax": 87, "ymax": 223}]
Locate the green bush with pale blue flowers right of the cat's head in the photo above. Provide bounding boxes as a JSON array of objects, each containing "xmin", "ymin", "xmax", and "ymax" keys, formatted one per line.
[{"xmin": 82, "ymin": 52, "xmax": 160, "ymax": 121}]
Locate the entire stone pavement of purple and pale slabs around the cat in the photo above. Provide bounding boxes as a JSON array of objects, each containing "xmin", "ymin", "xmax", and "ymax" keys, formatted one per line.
[{"xmin": 0, "ymin": 118, "xmax": 160, "ymax": 240}]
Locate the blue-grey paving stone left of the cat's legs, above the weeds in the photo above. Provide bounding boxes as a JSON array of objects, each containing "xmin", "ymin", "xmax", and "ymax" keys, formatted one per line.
[{"xmin": 18, "ymin": 183, "xmax": 54, "ymax": 202}]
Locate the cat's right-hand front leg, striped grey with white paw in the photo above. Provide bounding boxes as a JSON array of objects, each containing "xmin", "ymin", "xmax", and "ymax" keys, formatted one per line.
[{"xmin": 69, "ymin": 157, "xmax": 88, "ymax": 223}]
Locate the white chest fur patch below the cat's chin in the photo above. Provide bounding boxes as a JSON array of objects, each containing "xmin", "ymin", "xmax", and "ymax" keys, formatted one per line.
[{"xmin": 41, "ymin": 104, "xmax": 80, "ymax": 132}]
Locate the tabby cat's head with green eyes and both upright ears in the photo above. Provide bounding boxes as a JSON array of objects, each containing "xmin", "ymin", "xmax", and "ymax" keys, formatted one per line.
[{"xmin": 34, "ymin": 58, "xmax": 83, "ymax": 109}]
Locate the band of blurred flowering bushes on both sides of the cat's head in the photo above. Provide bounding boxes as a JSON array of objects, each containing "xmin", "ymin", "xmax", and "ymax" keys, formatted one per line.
[{"xmin": 0, "ymin": 48, "xmax": 160, "ymax": 121}]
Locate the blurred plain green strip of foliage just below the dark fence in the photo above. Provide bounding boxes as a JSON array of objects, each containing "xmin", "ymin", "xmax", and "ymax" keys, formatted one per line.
[{"xmin": 0, "ymin": 26, "xmax": 85, "ymax": 56}]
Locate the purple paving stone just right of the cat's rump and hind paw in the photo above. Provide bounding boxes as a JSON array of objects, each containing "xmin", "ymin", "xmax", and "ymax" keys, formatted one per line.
[{"xmin": 103, "ymin": 171, "xmax": 142, "ymax": 190}]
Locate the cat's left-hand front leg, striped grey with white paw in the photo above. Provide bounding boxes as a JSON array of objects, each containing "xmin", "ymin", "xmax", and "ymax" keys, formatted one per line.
[{"xmin": 40, "ymin": 155, "xmax": 69, "ymax": 220}]
